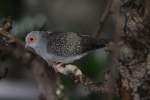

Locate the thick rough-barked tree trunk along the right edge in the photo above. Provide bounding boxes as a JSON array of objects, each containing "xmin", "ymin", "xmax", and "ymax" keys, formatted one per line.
[{"xmin": 112, "ymin": 0, "xmax": 150, "ymax": 100}]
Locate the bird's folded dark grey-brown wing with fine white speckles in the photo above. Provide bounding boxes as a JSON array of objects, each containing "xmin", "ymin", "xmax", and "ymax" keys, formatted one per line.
[{"xmin": 47, "ymin": 32, "xmax": 103, "ymax": 57}]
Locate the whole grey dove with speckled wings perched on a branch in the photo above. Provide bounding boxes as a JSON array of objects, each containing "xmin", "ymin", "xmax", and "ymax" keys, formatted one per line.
[{"xmin": 25, "ymin": 31, "xmax": 108, "ymax": 71}]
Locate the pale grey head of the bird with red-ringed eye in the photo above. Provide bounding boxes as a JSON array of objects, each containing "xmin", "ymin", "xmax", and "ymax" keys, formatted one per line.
[{"xmin": 25, "ymin": 31, "xmax": 41, "ymax": 49}]
